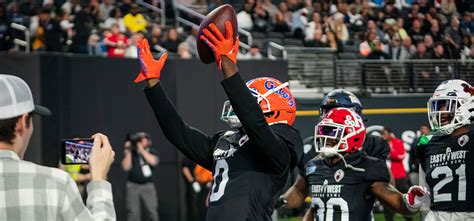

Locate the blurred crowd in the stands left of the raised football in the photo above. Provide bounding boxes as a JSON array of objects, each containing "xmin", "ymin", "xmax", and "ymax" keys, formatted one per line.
[{"xmin": 0, "ymin": 0, "xmax": 196, "ymax": 58}]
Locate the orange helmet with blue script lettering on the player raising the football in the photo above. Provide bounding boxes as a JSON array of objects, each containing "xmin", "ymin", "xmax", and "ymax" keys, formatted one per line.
[{"xmin": 247, "ymin": 77, "xmax": 296, "ymax": 125}]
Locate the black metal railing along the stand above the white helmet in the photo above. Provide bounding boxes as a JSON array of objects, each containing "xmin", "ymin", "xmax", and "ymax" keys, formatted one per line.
[{"xmin": 330, "ymin": 59, "xmax": 466, "ymax": 94}]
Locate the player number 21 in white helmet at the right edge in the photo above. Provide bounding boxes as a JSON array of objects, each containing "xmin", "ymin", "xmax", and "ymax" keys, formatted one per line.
[{"xmin": 415, "ymin": 80, "xmax": 474, "ymax": 221}]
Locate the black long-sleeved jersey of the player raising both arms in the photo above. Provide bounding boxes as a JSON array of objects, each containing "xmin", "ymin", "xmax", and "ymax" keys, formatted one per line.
[{"xmin": 145, "ymin": 74, "xmax": 303, "ymax": 221}]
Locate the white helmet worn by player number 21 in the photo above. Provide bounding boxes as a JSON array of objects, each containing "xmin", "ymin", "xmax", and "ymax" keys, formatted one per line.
[{"xmin": 428, "ymin": 80, "xmax": 474, "ymax": 135}]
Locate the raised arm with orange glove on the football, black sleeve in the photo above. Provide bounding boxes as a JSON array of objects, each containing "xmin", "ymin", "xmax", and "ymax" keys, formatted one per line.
[{"xmin": 200, "ymin": 21, "xmax": 290, "ymax": 174}]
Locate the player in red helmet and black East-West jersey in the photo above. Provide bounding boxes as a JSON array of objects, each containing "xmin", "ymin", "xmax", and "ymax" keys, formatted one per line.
[{"xmin": 305, "ymin": 108, "xmax": 429, "ymax": 221}]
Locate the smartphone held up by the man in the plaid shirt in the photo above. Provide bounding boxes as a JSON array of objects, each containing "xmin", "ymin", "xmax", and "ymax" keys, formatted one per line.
[{"xmin": 61, "ymin": 138, "xmax": 94, "ymax": 165}]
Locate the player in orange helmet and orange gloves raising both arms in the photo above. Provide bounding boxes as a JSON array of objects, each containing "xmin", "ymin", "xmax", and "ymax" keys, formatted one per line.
[{"xmin": 136, "ymin": 22, "xmax": 303, "ymax": 221}]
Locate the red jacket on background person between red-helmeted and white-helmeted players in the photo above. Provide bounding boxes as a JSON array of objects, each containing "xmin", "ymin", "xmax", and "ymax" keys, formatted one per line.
[{"xmin": 388, "ymin": 137, "xmax": 407, "ymax": 180}]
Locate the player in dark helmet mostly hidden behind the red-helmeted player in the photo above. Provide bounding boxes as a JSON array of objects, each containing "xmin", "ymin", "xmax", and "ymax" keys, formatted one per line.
[{"xmin": 275, "ymin": 89, "xmax": 390, "ymax": 208}]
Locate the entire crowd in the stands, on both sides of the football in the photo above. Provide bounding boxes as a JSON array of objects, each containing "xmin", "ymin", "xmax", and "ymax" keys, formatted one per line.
[{"xmin": 0, "ymin": 0, "xmax": 474, "ymax": 60}]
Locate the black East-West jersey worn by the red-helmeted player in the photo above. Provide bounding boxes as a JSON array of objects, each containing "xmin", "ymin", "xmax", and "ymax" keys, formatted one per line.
[{"xmin": 305, "ymin": 151, "xmax": 390, "ymax": 221}]
